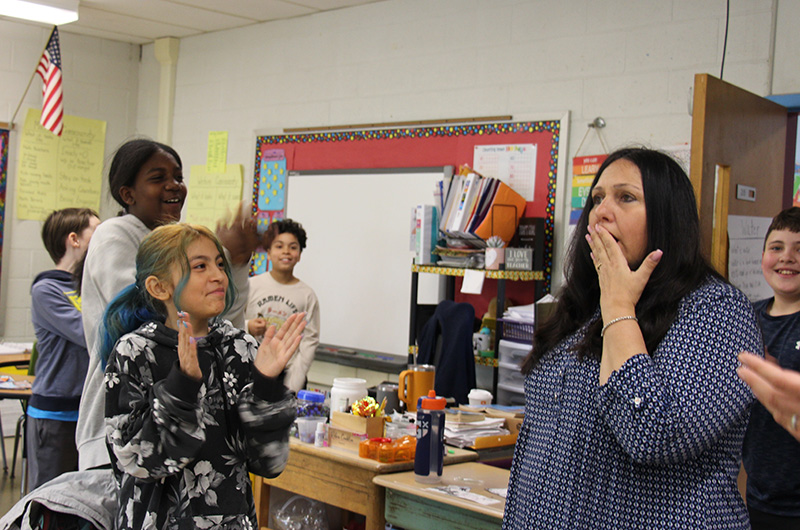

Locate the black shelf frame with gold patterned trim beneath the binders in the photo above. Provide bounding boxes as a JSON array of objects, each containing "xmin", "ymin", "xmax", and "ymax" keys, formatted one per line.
[{"xmin": 408, "ymin": 263, "xmax": 544, "ymax": 402}]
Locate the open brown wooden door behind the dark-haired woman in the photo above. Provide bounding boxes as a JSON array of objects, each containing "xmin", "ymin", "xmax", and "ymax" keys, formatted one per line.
[{"xmin": 690, "ymin": 74, "xmax": 787, "ymax": 277}]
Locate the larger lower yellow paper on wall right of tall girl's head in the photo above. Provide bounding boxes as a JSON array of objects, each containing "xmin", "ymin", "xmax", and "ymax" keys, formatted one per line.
[{"xmin": 186, "ymin": 164, "xmax": 244, "ymax": 230}]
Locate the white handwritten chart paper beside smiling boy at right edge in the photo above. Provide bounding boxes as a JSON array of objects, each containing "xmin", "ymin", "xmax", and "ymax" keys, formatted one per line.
[{"xmin": 728, "ymin": 215, "xmax": 772, "ymax": 302}]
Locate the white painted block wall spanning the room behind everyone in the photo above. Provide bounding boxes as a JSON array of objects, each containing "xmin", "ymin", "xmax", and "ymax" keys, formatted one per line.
[{"xmin": 0, "ymin": 0, "xmax": 800, "ymax": 340}]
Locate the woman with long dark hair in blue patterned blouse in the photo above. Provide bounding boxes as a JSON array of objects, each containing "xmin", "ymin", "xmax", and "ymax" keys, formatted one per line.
[{"xmin": 503, "ymin": 148, "xmax": 763, "ymax": 530}]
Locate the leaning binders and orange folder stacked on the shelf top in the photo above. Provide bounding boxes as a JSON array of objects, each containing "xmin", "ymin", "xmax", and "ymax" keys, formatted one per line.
[{"xmin": 439, "ymin": 166, "xmax": 526, "ymax": 248}]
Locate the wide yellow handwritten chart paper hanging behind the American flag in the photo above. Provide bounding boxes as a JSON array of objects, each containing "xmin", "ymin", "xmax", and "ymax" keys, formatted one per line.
[{"xmin": 16, "ymin": 108, "xmax": 106, "ymax": 220}]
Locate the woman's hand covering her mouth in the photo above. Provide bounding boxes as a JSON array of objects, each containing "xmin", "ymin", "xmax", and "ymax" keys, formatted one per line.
[{"xmin": 586, "ymin": 224, "xmax": 663, "ymax": 320}]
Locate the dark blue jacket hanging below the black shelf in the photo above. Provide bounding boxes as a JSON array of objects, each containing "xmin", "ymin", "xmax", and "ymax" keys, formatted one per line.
[{"xmin": 417, "ymin": 300, "xmax": 475, "ymax": 403}]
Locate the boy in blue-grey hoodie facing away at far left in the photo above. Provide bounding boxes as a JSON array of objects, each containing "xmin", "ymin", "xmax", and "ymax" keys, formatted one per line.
[{"xmin": 26, "ymin": 208, "xmax": 100, "ymax": 490}]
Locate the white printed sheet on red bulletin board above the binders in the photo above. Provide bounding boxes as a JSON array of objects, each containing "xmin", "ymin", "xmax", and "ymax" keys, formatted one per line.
[{"xmin": 472, "ymin": 144, "xmax": 536, "ymax": 202}]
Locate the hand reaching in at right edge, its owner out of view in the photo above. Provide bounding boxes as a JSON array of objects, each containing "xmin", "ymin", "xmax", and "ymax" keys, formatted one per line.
[{"xmin": 736, "ymin": 352, "xmax": 800, "ymax": 441}]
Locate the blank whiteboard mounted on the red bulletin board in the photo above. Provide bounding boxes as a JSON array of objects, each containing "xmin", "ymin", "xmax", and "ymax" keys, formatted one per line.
[{"xmin": 286, "ymin": 168, "xmax": 444, "ymax": 357}]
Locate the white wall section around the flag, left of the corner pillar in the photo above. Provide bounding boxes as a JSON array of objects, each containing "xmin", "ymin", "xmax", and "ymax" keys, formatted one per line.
[{"xmin": 0, "ymin": 20, "xmax": 140, "ymax": 341}]
